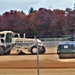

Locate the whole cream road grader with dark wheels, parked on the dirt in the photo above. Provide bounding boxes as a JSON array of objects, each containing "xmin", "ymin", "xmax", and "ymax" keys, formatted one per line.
[{"xmin": 0, "ymin": 31, "xmax": 46, "ymax": 55}]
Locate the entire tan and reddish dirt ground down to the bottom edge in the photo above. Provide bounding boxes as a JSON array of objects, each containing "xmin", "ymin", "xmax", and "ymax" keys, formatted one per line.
[{"xmin": 0, "ymin": 48, "xmax": 75, "ymax": 75}]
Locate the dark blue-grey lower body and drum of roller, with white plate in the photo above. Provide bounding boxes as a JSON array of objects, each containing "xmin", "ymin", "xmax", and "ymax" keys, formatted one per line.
[{"xmin": 57, "ymin": 41, "xmax": 75, "ymax": 58}]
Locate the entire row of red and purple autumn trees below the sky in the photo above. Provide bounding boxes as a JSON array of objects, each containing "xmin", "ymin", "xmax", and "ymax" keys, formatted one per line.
[{"xmin": 0, "ymin": 8, "xmax": 75, "ymax": 37}]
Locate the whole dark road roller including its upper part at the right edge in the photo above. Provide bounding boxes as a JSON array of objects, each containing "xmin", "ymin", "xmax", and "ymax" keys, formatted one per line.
[{"xmin": 57, "ymin": 28, "xmax": 75, "ymax": 58}]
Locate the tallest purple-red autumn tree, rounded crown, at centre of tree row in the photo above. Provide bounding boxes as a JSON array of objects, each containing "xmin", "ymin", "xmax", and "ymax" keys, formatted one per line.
[{"xmin": 35, "ymin": 8, "xmax": 53, "ymax": 36}]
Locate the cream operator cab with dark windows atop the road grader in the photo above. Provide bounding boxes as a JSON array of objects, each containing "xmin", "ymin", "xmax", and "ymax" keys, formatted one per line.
[{"xmin": 0, "ymin": 31, "xmax": 20, "ymax": 43}]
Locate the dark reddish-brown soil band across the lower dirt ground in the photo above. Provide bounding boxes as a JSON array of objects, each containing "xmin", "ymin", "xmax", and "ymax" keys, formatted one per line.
[{"xmin": 0, "ymin": 60, "xmax": 75, "ymax": 69}]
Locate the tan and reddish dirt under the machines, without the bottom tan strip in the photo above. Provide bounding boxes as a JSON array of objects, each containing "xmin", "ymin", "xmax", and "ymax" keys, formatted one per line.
[{"xmin": 0, "ymin": 48, "xmax": 75, "ymax": 69}]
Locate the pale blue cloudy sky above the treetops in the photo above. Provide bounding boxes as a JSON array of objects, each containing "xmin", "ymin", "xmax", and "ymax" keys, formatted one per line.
[{"xmin": 0, "ymin": 0, "xmax": 75, "ymax": 14}]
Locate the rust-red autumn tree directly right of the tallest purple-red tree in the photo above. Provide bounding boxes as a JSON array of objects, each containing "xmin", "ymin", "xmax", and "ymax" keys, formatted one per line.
[{"xmin": 51, "ymin": 9, "xmax": 65, "ymax": 35}]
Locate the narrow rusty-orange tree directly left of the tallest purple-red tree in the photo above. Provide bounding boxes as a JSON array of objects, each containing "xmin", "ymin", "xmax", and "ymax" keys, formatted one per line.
[{"xmin": 26, "ymin": 13, "xmax": 36, "ymax": 37}]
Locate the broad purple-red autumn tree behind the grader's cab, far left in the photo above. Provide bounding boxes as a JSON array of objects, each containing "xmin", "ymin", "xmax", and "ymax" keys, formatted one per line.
[{"xmin": 2, "ymin": 10, "xmax": 26, "ymax": 32}]
